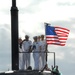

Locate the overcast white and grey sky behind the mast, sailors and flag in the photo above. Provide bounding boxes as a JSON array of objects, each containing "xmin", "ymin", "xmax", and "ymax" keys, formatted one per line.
[{"xmin": 0, "ymin": 0, "xmax": 75, "ymax": 75}]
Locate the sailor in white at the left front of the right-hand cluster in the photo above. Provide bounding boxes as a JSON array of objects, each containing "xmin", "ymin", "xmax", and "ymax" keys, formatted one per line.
[{"xmin": 33, "ymin": 36, "xmax": 41, "ymax": 70}]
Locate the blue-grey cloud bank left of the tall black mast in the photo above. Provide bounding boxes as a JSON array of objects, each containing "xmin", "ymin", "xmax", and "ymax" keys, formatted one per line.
[{"xmin": 0, "ymin": 24, "xmax": 11, "ymax": 70}]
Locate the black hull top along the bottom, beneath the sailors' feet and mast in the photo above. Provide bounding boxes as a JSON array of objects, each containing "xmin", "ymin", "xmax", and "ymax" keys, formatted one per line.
[{"xmin": 0, "ymin": 71, "xmax": 51, "ymax": 75}]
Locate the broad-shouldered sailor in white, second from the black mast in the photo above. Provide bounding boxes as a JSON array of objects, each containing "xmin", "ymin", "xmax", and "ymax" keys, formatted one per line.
[{"xmin": 22, "ymin": 35, "xmax": 32, "ymax": 70}]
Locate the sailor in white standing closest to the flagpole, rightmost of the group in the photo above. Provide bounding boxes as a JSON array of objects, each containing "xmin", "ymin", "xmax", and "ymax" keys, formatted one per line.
[{"xmin": 41, "ymin": 35, "xmax": 47, "ymax": 69}]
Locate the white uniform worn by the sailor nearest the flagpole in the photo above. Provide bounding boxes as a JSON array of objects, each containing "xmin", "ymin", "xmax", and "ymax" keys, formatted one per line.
[{"xmin": 41, "ymin": 40, "xmax": 46, "ymax": 68}]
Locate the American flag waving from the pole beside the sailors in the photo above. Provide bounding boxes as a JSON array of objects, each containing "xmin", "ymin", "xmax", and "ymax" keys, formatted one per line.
[{"xmin": 46, "ymin": 25, "xmax": 70, "ymax": 46}]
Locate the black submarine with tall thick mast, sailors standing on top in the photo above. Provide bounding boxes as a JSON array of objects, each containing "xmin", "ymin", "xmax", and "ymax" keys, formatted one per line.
[{"xmin": 0, "ymin": 0, "xmax": 55, "ymax": 75}]
